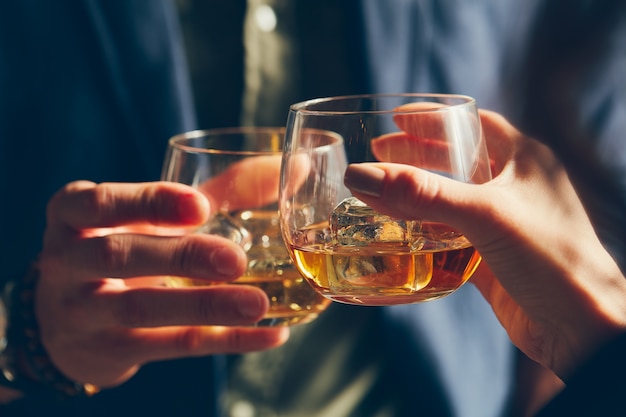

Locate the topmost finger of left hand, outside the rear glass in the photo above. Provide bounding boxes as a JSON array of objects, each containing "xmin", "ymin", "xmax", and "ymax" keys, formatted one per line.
[{"xmin": 47, "ymin": 181, "xmax": 209, "ymax": 229}]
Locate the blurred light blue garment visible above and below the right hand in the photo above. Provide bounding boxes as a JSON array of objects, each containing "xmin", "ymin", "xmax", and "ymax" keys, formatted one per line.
[{"xmin": 362, "ymin": 0, "xmax": 626, "ymax": 416}]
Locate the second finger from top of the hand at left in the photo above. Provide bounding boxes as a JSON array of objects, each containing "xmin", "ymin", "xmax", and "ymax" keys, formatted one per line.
[{"xmin": 51, "ymin": 234, "xmax": 247, "ymax": 280}]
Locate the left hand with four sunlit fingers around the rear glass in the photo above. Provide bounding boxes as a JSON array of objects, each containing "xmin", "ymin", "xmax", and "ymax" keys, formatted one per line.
[{"xmin": 36, "ymin": 181, "xmax": 288, "ymax": 387}]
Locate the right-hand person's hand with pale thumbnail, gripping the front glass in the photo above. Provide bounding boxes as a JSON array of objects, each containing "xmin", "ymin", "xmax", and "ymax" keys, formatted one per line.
[{"xmin": 345, "ymin": 111, "xmax": 626, "ymax": 378}]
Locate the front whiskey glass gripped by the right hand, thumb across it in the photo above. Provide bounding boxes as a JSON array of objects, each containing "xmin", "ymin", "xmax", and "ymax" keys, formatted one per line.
[{"xmin": 279, "ymin": 94, "xmax": 491, "ymax": 305}]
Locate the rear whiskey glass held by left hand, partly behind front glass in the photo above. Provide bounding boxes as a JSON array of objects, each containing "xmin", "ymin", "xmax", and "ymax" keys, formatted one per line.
[{"xmin": 161, "ymin": 127, "xmax": 330, "ymax": 326}]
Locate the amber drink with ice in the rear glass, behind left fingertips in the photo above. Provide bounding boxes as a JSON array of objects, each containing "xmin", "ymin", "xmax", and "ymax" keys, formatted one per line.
[{"xmin": 169, "ymin": 210, "xmax": 331, "ymax": 326}]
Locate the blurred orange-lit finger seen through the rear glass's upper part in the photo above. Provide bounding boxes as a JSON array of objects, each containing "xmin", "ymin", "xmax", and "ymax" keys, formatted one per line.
[{"xmin": 200, "ymin": 155, "xmax": 281, "ymax": 211}]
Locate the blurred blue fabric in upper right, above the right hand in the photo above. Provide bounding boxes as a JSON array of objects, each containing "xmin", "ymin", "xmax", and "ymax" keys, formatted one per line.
[{"xmin": 362, "ymin": 0, "xmax": 626, "ymax": 270}]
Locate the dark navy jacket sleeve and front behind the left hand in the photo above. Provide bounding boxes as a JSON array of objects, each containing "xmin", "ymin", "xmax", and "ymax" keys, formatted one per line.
[{"xmin": 0, "ymin": 0, "xmax": 218, "ymax": 416}]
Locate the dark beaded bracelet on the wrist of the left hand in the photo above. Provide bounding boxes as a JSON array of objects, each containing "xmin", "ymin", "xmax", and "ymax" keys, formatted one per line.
[{"xmin": 3, "ymin": 265, "xmax": 99, "ymax": 397}]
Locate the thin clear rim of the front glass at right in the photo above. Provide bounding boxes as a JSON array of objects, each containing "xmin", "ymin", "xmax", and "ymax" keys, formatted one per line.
[{"xmin": 289, "ymin": 93, "xmax": 476, "ymax": 116}]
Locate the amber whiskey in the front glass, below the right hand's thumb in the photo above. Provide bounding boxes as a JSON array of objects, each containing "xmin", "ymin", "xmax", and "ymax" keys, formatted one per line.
[{"xmin": 290, "ymin": 224, "xmax": 481, "ymax": 305}]
